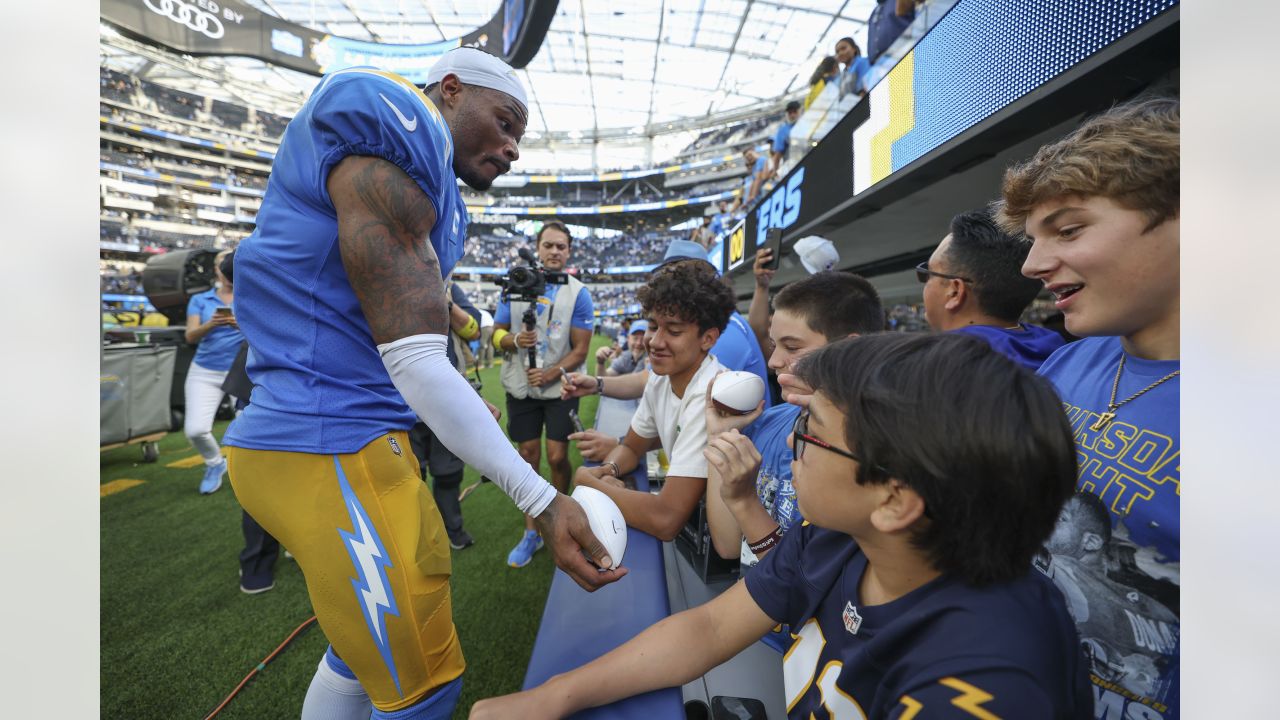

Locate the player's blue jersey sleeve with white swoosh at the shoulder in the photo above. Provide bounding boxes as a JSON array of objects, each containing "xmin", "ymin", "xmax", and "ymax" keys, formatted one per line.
[{"xmin": 304, "ymin": 68, "xmax": 453, "ymax": 219}]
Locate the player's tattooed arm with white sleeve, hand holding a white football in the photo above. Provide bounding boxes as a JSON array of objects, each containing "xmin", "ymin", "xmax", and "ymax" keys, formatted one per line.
[{"xmin": 320, "ymin": 155, "xmax": 626, "ymax": 589}]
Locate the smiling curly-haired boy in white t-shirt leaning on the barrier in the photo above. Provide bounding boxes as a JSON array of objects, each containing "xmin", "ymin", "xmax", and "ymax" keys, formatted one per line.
[{"xmin": 573, "ymin": 263, "xmax": 733, "ymax": 541}]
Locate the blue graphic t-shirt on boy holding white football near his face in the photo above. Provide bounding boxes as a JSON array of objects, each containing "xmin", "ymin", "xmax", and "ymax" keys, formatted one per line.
[{"xmin": 741, "ymin": 402, "xmax": 801, "ymax": 566}]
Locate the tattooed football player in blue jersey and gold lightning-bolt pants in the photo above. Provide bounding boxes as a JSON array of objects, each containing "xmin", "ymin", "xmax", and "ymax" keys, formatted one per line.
[{"xmin": 224, "ymin": 49, "xmax": 623, "ymax": 720}]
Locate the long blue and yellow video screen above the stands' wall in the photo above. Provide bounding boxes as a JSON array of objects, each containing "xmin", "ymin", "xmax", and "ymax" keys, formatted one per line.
[{"xmin": 724, "ymin": 0, "xmax": 1178, "ymax": 272}]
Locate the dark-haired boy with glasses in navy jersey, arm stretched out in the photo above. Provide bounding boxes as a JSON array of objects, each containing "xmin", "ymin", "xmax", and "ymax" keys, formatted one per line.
[{"xmin": 471, "ymin": 333, "xmax": 1093, "ymax": 720}]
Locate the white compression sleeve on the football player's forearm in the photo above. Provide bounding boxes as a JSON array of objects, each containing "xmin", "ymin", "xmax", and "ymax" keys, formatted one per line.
[{"xmin": 378, "ymin": 334, "xmax": 556, "ymax": 516}]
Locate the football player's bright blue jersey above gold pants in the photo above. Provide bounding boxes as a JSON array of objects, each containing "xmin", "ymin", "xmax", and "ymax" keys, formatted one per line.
[{"xmin": 225, "ymin": 68, "xmax": 467, "ymax": 454}]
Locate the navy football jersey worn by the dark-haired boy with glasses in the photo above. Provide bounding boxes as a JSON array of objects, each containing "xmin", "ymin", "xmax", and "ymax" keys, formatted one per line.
[{"xmin": 745, "ymin": 524, "xmax": 1092, "ymax": 720}]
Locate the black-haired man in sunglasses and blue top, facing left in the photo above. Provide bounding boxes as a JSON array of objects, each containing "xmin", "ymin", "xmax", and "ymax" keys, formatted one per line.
[{"xmin": 915, "ymin": 204, "xmax": 1064, "ymax": 370}]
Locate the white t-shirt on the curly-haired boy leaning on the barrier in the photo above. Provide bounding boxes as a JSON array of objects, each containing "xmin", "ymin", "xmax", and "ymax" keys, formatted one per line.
[{"xmin": 631, "ymin": 355, "xmax": 727, "ymax": 478}]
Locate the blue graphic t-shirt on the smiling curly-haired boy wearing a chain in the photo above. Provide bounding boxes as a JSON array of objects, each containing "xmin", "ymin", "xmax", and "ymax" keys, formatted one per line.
[{"xmin": 1037, "ymin": 337, "xmax": 1181, "ymax": 720}]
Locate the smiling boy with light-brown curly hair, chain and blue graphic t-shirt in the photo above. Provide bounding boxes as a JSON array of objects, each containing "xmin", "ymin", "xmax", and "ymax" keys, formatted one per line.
[{"xmin": 1001, "ymin": 99, "xmax": 1181, "ymax": 720}]
